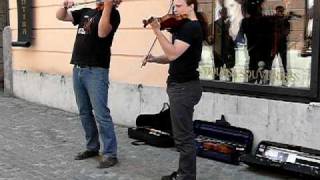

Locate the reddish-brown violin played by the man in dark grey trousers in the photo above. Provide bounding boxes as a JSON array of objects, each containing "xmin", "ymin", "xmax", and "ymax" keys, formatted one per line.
[{"xmin": 142, "ymin": 14, "xmax": 188, "ymax": 30}]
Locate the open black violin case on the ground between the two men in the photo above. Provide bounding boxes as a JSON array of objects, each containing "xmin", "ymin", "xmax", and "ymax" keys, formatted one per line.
[{"xmin": 128, "ymin": 103, "xmax": 174, "ymax": 147}]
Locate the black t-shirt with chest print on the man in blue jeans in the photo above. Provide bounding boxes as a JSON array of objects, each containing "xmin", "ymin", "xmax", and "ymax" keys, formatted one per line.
[{"xmin": 71, "ymin": 8, "xmax": 120, "ymax": 68}]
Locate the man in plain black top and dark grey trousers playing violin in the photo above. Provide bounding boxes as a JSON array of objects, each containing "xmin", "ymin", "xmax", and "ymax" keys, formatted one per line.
[{"xmin": 143, "ymin": 0, "xmax": 207, "ymax": 180}]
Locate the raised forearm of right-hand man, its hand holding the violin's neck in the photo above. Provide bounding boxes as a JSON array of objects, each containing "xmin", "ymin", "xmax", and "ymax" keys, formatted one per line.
[{"xmin": 154, "ymin": 29, "xmax": 178, "ymax": 61}]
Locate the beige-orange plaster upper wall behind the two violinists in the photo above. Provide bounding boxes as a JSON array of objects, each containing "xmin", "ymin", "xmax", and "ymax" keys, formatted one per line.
[{"xmin": 9, "ymin": 0, "xmax": 170, "ymax": 87}]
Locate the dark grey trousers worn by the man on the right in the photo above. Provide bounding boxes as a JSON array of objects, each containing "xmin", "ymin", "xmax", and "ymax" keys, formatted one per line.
[{"xmin": 167, "ymin": 81, "xmax": 202, "ymax": 180}]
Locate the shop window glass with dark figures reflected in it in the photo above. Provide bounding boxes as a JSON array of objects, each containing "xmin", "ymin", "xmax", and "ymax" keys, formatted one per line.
[{"xmin": 199, "ymin": 0, "xmax": 313, "ymax": 88}]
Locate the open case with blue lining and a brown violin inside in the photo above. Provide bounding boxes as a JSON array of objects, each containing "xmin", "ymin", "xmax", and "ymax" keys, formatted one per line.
[{"xmin": 193, "ymin": 115, "xmax": 253, "ymax": 164}]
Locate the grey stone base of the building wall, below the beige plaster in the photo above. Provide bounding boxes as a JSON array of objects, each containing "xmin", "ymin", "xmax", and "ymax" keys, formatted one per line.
[{"xmin": 13, "ymin": 70, "xmax": 320, "ymax": 149}]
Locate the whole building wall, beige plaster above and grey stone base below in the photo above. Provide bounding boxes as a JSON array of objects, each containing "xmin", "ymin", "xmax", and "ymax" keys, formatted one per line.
[{"xmin": 6, "ymin": 0, "xmax": 320, "ymax": 149}]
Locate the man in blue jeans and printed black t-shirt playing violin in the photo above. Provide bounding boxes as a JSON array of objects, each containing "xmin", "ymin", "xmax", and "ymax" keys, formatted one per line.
[{"xmin": 56, "ymin": 0, "xmax": 121, "ymax": 168}]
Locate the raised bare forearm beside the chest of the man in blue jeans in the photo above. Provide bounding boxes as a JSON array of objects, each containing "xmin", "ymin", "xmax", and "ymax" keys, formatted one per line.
[{"xmin": 98, "ymin": 2, "xmax": 112, "ymax": 38}]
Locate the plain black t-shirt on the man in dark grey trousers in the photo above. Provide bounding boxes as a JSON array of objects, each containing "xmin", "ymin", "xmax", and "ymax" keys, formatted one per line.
[{"xmin": 167, "ymin": 20, "xmax": 203, "ymax": 84}]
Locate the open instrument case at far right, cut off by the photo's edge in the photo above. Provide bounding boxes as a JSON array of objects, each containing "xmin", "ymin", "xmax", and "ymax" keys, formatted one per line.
[{"xmin": 240, "ymin": 141, "xmax": 320, "ymax": 179}]
